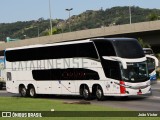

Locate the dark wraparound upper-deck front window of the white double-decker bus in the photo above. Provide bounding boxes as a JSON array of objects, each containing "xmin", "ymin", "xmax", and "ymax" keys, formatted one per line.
[{"xmin": 94, "ymin": 38, "xmax": 144, "ymax": 59}]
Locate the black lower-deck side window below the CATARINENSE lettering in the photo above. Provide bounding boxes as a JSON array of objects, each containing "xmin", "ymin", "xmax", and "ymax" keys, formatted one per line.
[{"xmin": 32, "ymin": 68, "xmax": 99, "ymax": 81}]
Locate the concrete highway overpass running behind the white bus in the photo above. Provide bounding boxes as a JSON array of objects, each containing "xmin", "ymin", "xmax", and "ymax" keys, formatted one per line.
[{"xmin": 0, "ymin": 20, "xmax": 160, "ymax": 52}]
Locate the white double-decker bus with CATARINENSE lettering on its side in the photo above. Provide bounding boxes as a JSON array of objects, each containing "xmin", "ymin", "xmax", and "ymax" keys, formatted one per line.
[{"xmin": 5, "ymin": 38, "xmax": 151, "ymax": 100}]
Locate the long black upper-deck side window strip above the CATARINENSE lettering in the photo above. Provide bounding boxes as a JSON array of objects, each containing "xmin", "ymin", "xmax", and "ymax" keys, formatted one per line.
[{"xmin": 6, "ymin": 42, "xmax": 98, "ymax": 62}]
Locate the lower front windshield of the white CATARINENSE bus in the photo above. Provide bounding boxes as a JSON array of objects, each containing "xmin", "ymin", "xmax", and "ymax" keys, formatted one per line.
[{"xmin": 121, "ymin": 62, "xmax": 149, "ymax": 82}]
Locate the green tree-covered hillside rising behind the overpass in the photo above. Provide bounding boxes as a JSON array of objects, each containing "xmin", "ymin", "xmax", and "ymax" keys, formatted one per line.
[{"xmin": 0, "ymin": 6, "xmax": 160, "ymax": 41}]
